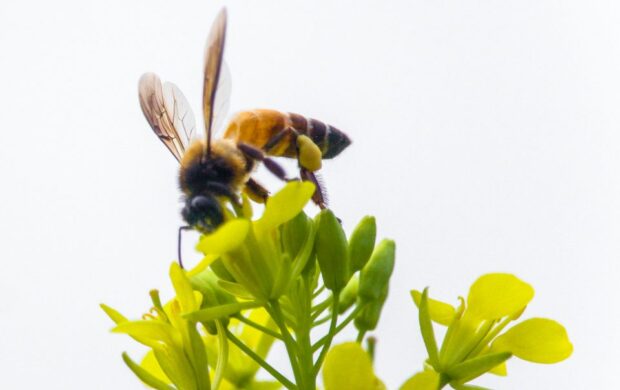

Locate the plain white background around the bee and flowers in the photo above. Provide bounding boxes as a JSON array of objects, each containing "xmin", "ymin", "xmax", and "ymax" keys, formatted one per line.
[{"xmin": 0, "ymin": 0, "xmax": 620, "ymax": 389}]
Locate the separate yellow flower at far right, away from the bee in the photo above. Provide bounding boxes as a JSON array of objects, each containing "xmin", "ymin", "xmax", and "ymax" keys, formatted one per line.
[{"xmin": 402, "ymin": 273, "xmax": 573, "ymax": 390}]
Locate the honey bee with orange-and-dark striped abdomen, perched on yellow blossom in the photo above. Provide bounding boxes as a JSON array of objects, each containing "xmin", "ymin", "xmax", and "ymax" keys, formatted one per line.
[{"xmin": 138, "ymin": 9, "xmax": 351, "ymax": 244}]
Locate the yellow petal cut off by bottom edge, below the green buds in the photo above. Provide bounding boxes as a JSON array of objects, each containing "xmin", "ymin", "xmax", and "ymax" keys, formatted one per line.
[{"xmin": 323, "ymin": 342, "xmax": 381, "ymax": 390}]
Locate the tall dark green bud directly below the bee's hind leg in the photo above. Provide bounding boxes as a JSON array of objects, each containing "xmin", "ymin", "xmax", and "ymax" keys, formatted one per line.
[{"xmin": 315, "ymin": 209, "xmax": 349, "ymax": 291}]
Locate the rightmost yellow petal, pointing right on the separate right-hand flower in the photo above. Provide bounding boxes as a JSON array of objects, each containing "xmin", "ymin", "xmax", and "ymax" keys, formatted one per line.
[{"xmin": 492, "ymin": 318, "xmax": 573, "ymax": 363}]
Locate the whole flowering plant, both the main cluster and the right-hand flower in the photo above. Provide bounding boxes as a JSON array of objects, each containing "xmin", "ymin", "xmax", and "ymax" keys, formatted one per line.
[{"xmin": 101, "ymin": 182, "xmax": 572, "ymax": 390}]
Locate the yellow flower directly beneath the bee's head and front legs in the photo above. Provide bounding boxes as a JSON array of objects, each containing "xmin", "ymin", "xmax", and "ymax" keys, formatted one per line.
[{"xmin": 197, "ymin": 181, "xmax": 315, "ymax": 302}]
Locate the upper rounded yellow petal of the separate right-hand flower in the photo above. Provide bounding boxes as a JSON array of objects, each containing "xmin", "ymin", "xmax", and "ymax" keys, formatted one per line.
[{"xmin": 467, "ymin": 273, "xmax": 534, "ymax": 319}]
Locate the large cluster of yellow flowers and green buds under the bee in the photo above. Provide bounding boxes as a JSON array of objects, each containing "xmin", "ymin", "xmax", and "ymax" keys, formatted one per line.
[{"xmin": 102, "ymin": 182, "xmax": 395, "ymax": 390}]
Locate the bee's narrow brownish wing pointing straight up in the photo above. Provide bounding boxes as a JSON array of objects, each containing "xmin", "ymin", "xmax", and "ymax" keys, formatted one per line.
[{"xmin": 202, "ymin": 8, "xmax": 226, "ymax": 156}]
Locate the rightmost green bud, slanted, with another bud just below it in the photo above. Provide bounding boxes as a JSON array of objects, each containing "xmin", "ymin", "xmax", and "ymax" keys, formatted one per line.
[{"xmin": 358, "ymin": 239, "xmax": 396, "ymax": 301}]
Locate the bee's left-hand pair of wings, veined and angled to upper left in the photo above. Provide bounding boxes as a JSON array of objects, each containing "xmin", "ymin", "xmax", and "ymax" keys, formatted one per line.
[{"xmin": 138, "ymin": 73, "xmax": 196, "ymax": 161}]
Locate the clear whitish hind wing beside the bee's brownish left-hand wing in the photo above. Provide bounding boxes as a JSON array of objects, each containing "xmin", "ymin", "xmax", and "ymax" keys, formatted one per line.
[{"xmin": 163, "ymin": 82, "xmax": 198, "ymax": 149}]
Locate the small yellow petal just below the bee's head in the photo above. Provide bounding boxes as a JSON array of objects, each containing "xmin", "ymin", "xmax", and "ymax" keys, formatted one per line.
[{"xmin": 196, "ymin": 218, "xmax": 250, "ymax": 255}]
